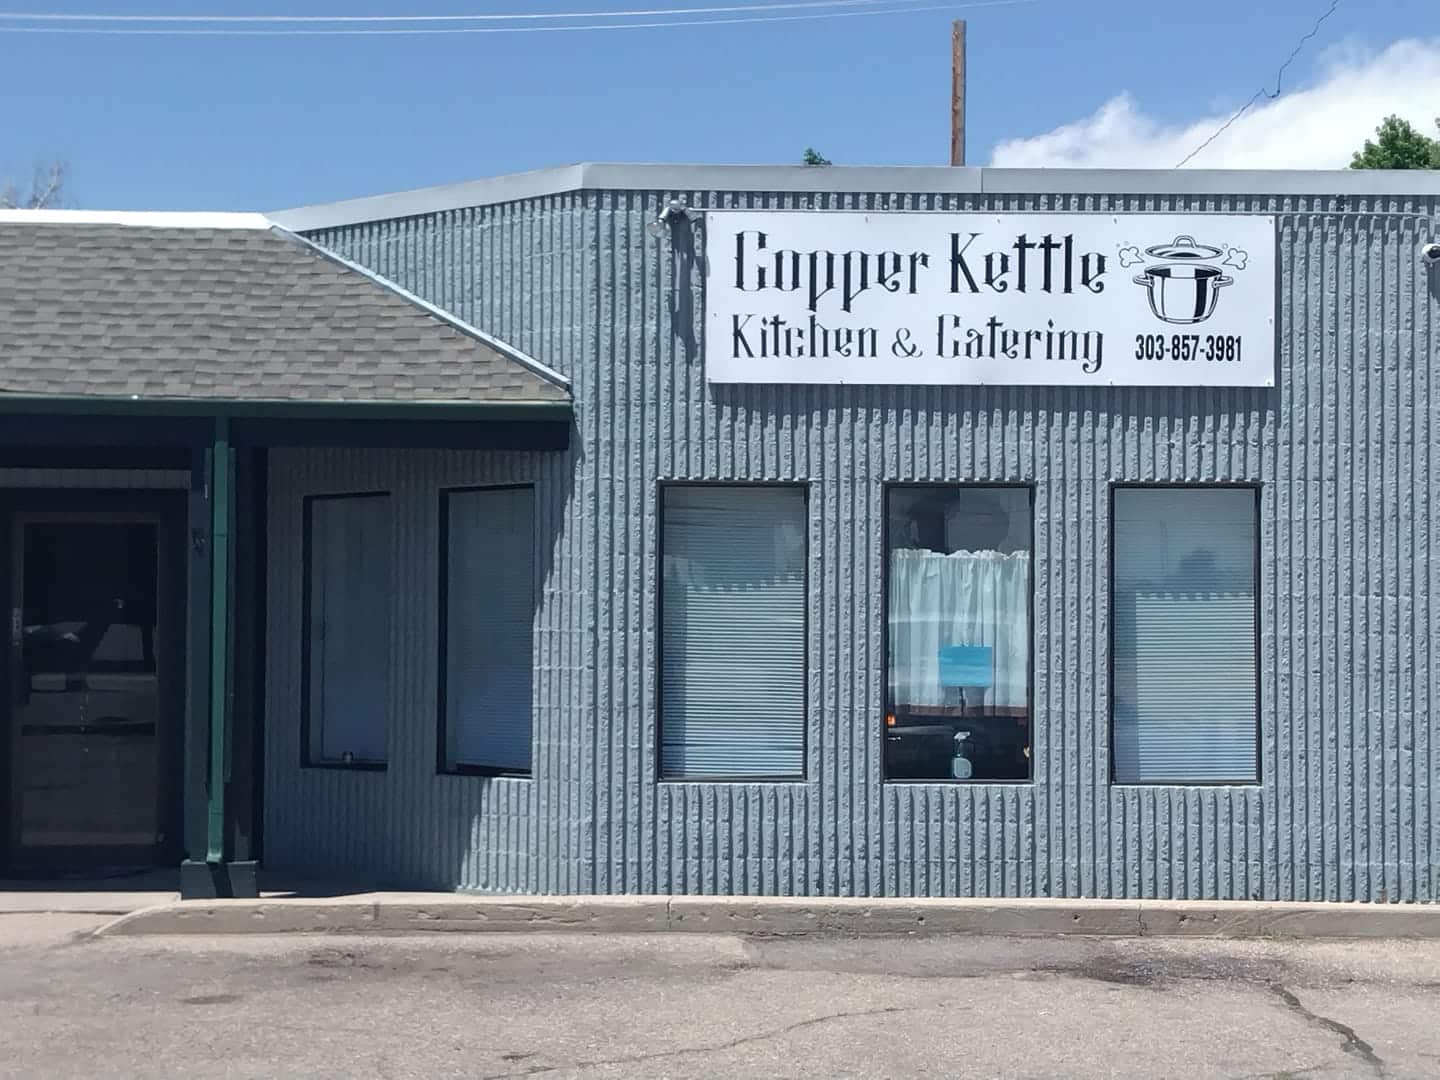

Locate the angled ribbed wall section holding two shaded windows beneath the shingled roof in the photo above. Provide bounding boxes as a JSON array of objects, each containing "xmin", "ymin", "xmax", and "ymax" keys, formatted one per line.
[{"xmin": 265, "ymin": 449, "xmax": 588, "ymax": 893}]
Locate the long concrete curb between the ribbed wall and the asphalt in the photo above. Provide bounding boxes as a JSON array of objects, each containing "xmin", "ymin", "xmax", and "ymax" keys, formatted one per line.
[{"xmin": 96, "ymin": 893, "xmax": 1440, "ymax": 939}]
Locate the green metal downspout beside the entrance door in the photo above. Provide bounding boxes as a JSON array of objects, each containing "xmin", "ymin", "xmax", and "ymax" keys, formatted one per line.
[{"xmin": 206, "ymin": 416, "xmax": 233, "ymax": 865}]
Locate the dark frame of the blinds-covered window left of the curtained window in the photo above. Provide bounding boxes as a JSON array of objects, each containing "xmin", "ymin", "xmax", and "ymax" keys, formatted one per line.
[{"xmin": 651, "ymin": 480, "xmax": 814, "ymax": 785}]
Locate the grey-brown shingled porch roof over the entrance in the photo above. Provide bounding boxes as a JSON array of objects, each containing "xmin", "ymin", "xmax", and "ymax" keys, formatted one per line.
[{"xmin": 0, "ymin": 213, "xmax": 570, "ymax": 405}]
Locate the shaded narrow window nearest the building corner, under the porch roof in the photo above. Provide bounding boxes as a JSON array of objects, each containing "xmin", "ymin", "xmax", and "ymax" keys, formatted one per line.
[{"xmin": 439, "ymin": 487, "xmax": 536, "ymax": 775}]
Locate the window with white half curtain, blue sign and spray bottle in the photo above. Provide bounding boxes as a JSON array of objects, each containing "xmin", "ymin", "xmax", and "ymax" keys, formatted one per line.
[{"xmin": 884, "ymin": 485, "xmax": 1031, "ymax": 780}]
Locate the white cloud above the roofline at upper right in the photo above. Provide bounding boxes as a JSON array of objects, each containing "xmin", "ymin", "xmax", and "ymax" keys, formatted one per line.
[{"xmin": 991, "ymin": 37, "xmax": 1440, "ymax": 168}]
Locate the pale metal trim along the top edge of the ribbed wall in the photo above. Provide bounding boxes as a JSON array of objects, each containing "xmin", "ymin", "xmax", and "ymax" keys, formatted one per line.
[{"xmin": 269, "ymin": 163, "xmax": 1440, "ymax": 232}]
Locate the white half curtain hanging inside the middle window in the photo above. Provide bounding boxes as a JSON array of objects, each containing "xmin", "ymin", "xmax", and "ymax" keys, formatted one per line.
[{"xmin": 890, "ymin": 549, "xmax": 1030, "ymax": 707}]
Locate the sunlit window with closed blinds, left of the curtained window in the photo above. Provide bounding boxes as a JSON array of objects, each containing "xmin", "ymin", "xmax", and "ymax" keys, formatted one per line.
[{"xmin": 660, "ymin": 485, "xmax": 805, "ymax": 779}]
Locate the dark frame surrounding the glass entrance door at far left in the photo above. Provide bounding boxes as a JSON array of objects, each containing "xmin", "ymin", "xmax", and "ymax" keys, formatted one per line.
[{"xmin": 0, "ymin": 488, "xmax": 189, "ymax": 876}]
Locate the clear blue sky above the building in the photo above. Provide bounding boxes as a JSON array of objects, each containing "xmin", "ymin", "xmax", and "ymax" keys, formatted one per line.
[{"xmin": 0, "ymin": 0, "xmax": 1440, "ymax": 210}]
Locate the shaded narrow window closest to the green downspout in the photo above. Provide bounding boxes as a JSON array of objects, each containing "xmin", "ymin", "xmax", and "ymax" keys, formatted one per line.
[{"xmin": 301, "ymin": 494, "xmax": 390, "ymax": 768}]
